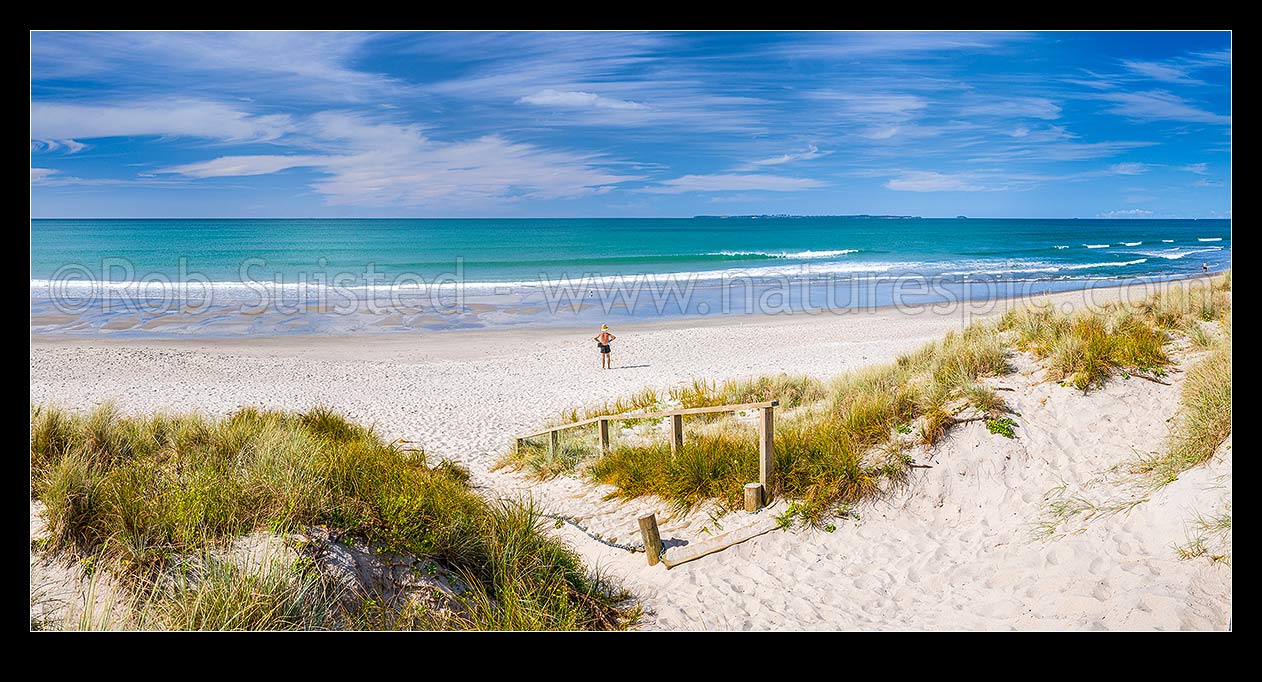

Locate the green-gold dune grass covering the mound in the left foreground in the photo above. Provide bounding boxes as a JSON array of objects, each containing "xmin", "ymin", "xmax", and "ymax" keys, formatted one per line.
[{"xmin": 30, "ymin": 405, "xmax": 636, "ymax": 629}]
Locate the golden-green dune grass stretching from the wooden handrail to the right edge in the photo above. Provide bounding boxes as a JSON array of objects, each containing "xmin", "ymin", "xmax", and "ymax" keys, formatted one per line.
[{"xmin": 501, "ymin": 273, "xmax": 1230, "ymax": 523}]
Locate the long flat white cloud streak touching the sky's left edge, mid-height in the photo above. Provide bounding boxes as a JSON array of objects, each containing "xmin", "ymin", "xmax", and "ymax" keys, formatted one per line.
[{"xmin": 30, "ymin": 101, "xmax": 293, "ymax": 145}]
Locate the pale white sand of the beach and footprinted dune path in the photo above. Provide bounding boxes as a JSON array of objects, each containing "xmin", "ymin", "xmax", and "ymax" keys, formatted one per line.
[{"xmin": 30, "ymin": 281, "xmax": 1232, "ymax": 630}]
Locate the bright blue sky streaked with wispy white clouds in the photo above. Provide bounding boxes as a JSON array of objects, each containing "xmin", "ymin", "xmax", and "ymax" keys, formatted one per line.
[{"xmin": 30, "ymin": 32, "xmax": 1232, "ymax": 217}]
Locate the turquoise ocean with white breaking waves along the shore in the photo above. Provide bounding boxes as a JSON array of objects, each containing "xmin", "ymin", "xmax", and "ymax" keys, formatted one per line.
[{"xmin": 30, "ymin": 216, "xmax": 1232, "ymax": 336}]
